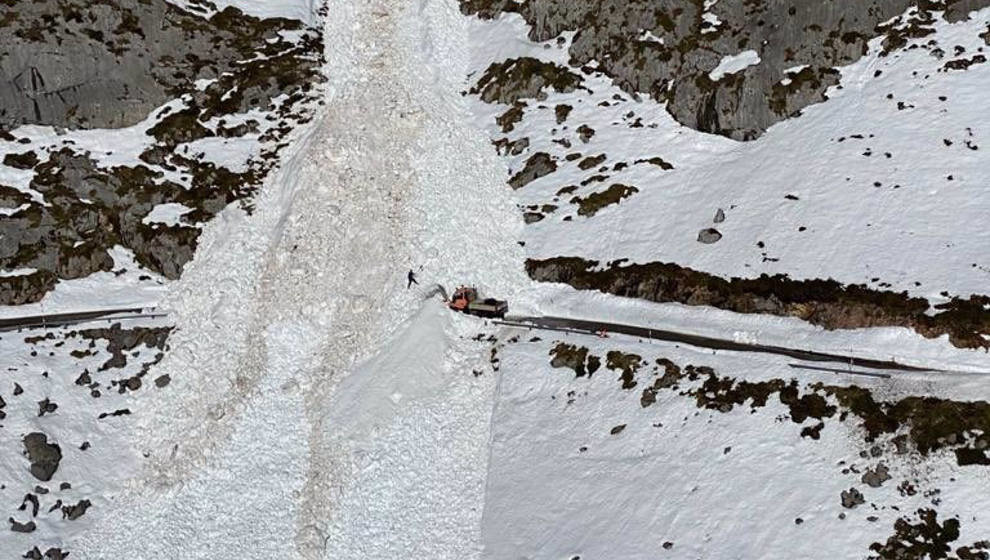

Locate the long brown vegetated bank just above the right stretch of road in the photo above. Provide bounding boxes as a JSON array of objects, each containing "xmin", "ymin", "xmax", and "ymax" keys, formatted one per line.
[{"xmin": 526, "ymin": 257, "xmax": 990, "ymax": 349}]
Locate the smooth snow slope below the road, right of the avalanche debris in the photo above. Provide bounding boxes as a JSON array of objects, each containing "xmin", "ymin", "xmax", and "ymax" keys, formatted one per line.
[{"xmin": 484, "ymin": 331, "xmax": 990, "ymax": 559}]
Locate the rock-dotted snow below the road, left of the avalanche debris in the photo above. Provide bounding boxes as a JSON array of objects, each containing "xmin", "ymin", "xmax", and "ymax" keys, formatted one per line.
[{"xmin": 0, "ymin": 310, "xmax": 174, "ymax": 557}]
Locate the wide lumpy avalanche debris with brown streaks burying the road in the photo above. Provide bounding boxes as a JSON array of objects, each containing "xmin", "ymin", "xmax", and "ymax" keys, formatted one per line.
[{"xmin": 76, "ymin": 0, "xmax": 528, "ymax": 559}]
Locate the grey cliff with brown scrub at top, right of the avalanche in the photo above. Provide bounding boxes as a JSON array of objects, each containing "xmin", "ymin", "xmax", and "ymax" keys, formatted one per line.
[{"xmin": 461, "ymin": 0, "xmax": 990, "ymax": 140}]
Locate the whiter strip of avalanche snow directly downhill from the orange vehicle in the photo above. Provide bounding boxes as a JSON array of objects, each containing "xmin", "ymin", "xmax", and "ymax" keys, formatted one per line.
[{"xmin": 325, "ymin": 301, "xmax": 495, "ymax": 559}]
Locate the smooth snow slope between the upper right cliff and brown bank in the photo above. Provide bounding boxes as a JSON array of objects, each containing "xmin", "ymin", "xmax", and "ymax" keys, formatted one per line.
[{"xmin": 473, "ymin": 10, "xmax": 990, "ymax": 303}]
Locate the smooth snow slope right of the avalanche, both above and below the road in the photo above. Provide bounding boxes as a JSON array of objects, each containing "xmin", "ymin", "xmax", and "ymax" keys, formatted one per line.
[{"xmin": 462, "ymin": 5, "xmax": 990, "ymax": 559}]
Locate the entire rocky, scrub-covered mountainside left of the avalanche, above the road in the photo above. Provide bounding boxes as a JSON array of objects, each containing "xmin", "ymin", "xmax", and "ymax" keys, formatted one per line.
[{"xmin": 0, "ymin": 0, "xmax": 322, "ymax": 305}]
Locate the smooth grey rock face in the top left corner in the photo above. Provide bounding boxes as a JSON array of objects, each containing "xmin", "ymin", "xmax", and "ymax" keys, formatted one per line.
[{"xmin": 0, "ymin": 0, "xmax": 300, "ymax": 129}]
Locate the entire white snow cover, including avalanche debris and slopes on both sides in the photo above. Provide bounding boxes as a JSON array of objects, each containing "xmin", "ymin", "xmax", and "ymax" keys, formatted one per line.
[{"xmin": 0, "ymin": 0, "xmax": 990, "ymax": 560}]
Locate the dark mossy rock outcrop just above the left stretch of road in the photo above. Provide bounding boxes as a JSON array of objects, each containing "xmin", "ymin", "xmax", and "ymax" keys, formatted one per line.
[{"xmin": 0, "ymin": 149, "xmax": 211, "ymax": 298}]
